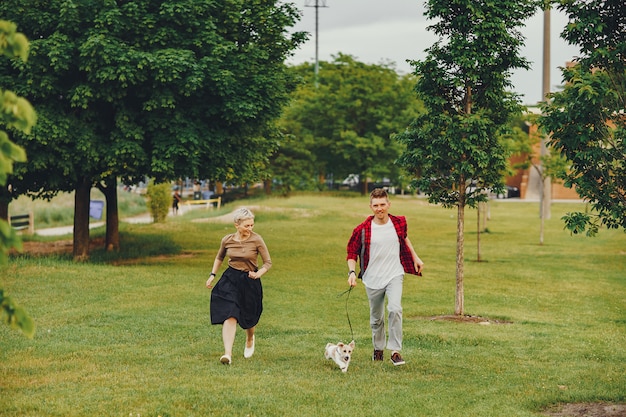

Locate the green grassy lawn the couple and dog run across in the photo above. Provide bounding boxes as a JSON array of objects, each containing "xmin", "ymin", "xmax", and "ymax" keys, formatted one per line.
[{"xmin": 0, "ymin": 196, "xmax": 626, "ymax": 417}]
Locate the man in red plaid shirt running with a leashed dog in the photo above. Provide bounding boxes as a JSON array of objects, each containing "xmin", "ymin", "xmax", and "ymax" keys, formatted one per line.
[{"xmin": 347, "ymin": 188, "xmax": 424, "ymax": 366}]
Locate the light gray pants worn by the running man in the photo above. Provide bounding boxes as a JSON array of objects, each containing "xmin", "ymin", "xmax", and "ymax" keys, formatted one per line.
[{"xmin": 365, "ymin": 275, "xmax": 404, "ymax": 351}]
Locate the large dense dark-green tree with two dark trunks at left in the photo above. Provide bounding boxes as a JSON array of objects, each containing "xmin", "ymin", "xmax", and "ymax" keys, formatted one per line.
[{"xmin": 0, "ymin": 0, "xmax": 305, "ymax": 259}]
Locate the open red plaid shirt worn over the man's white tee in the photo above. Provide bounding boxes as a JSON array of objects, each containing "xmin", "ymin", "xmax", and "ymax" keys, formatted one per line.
[{"xmin": 346, "ymin": 214, "xmax": 417, "ymax": 278}]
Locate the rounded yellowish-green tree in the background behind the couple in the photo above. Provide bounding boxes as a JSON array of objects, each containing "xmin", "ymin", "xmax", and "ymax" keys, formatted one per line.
[{"xmin": 280, "ymin": 54, "xmax": 423, "ymax": 192}]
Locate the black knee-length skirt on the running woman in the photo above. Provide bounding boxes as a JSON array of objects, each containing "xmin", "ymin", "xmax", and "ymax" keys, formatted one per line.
[{"xmin": 211, "ymin": 267, "xmax": 263, "ymax": 329}]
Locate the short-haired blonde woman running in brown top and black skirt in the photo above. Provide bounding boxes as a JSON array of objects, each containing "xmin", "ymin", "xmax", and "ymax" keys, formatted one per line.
[{"xmin": 206, "ymin": 208, "xmax": 272, "ymax": 365}]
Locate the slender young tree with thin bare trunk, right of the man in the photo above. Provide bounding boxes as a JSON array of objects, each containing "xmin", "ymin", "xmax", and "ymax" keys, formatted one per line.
[{"xmin": 398, "ymin": 0, "xmax": 537, "ymax": 315}]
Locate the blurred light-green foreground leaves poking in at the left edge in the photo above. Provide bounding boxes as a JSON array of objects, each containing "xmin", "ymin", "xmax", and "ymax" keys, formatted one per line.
[{"xmin": 0, "ymin": 20, "xmax": 37, "ymax": 337}]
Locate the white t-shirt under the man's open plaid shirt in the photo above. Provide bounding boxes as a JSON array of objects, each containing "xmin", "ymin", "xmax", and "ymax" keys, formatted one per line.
[{"xmin": 363, "ymin": 219, "xmax": 404, "ymax": 290}]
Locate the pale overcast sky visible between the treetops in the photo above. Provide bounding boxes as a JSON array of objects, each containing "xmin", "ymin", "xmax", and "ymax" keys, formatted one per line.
[{"xmin": 288, "ymin": 0, "xmax": 578, "ymax": 104}]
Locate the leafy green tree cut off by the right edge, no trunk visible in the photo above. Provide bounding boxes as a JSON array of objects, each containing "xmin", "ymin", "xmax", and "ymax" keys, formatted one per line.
[{"xmin": 539, "ymin": 0, "xmax": 626, "ymax": 236}]
